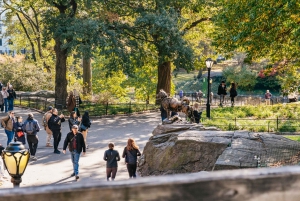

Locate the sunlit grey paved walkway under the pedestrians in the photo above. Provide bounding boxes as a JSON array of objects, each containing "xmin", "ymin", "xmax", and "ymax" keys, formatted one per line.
[{"xmin": 0, "ymin": 108, "xmax": 160, "ymax": 189}]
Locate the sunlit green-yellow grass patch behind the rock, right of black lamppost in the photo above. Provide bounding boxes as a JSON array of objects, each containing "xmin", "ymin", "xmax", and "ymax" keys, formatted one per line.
[{"xmin": 202, "ymin": 104, "xmax": 300, "ymax": 132}]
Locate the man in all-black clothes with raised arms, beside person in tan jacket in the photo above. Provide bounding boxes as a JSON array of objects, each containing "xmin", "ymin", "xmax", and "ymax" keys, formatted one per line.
[{"xmin": 48, "ymin": 108, "xmax": 65, "ymax": 154}]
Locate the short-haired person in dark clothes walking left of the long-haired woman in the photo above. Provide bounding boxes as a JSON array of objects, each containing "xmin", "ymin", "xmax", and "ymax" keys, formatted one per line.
[{"xmin": 103, "ymin": 142, "xmax": 120, "ymax": 181}]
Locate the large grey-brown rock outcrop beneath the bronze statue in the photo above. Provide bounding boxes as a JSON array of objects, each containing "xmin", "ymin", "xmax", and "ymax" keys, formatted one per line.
[{"xmin": 138, "ymin": 124, "xmax": 300, "ymax": 176}]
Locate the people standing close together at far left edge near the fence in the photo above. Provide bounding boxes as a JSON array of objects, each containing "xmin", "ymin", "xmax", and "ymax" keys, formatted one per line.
[{"xmin": 0, "ymin": 81, "xmax": 17, "ymax": 112}]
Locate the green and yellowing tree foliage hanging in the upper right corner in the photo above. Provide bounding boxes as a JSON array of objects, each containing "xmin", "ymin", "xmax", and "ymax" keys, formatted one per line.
[{"xmin": 215, "ymin": 0, "xmax": 300, "ymax": 90}]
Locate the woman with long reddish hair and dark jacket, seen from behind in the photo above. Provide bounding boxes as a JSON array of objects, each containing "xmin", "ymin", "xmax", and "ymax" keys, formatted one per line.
[{"xmin": 122, "ymin": 138, "xmax": 141, "ymax": 178}]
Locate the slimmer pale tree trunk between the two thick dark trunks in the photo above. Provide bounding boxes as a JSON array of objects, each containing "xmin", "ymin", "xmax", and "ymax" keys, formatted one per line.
[{"xmin": 82, "ymin": 57, "xmax": 92, "ymax": 94}]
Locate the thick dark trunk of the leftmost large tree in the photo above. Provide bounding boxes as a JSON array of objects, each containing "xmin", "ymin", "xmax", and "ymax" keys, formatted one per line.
[{"xmin": 54, "ymin": 38, "xmax": 68, "ymax": 109}]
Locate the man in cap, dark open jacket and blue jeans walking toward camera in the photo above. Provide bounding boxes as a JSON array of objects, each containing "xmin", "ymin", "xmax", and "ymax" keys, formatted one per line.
[{"xmin": 63, "ymin": 125, "xmax": 85, "ymax": 179}]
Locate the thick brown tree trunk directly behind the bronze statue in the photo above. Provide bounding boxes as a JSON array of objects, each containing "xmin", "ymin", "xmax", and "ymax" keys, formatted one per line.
[{"xmin": 155, "ymin": 61, "xmax": 171, "ymax": 104}]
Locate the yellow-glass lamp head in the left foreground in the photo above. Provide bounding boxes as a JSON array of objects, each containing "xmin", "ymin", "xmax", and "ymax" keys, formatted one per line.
[{"xmin": 1, "ymin": 140, "xmax": 30, "ymax": 188}]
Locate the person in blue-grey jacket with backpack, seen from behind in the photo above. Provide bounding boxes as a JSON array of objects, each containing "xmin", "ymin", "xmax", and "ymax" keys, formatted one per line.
[{"xmin": 23, "ymin": 113, "xmax": 40, "ymax": 161}]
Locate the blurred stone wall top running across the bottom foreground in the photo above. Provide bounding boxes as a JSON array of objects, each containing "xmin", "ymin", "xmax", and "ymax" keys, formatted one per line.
[{"xmin": 0, "ymin": 166, "xmax": 300, "ymax": 201}]
